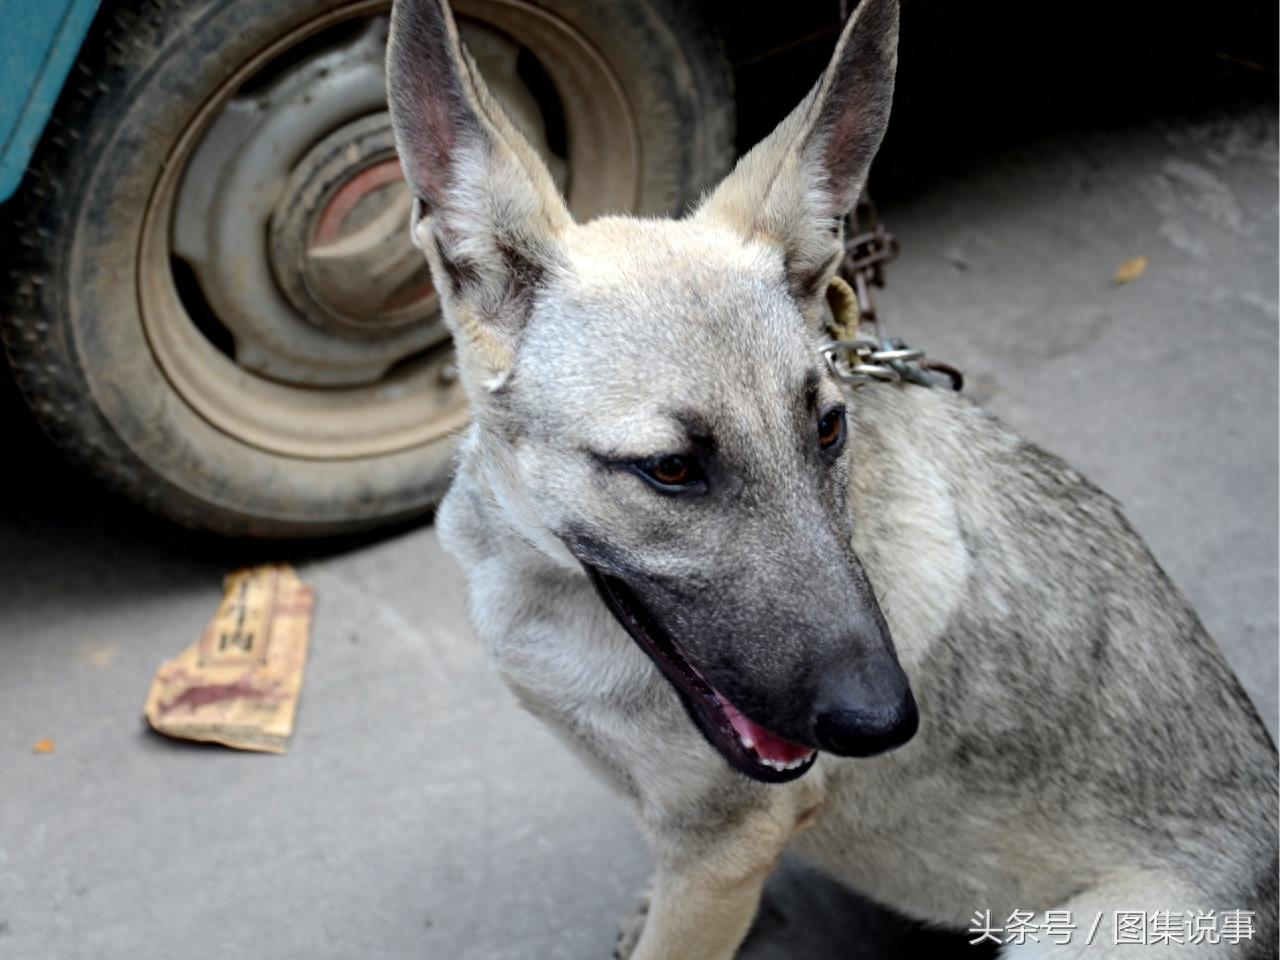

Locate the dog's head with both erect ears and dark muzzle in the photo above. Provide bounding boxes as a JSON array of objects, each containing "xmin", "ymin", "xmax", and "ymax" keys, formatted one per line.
[{"xmin": 388, "ymin": 0, "xmax": 916, "ymax": 781}]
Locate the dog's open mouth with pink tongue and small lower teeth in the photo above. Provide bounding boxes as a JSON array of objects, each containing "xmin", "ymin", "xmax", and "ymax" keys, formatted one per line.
[{"xmin": 586, "ymin": 566, "xmax": 818, "ymax": 783}]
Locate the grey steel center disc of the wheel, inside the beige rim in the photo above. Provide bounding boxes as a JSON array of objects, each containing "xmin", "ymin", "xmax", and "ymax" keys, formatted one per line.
[{"xmin": 173, "ymin": 17, "xmax": 448, "ymax": 387}]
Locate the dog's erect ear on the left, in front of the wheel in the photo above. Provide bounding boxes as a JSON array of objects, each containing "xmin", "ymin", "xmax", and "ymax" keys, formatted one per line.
[{"xmin": 387, "ymin": 0, "xmax": 572, "ymax": 383}]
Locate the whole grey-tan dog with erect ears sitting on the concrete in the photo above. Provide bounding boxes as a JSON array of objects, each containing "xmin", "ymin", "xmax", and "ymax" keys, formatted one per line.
[{"xmin": 388, "ymin": 0, "xmax": 1276, "ymax": 960}]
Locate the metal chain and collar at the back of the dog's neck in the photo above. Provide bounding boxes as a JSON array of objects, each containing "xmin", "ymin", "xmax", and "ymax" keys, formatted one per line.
[{"xmin": 818, "ymin": 196, "xmax": 964, "ymax": 390}]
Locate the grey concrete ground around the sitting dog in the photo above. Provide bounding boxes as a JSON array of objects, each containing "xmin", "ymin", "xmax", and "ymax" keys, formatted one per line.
[{"xmin": 0, "ymin": 99, "xmax": 1277, "ymax": 960}]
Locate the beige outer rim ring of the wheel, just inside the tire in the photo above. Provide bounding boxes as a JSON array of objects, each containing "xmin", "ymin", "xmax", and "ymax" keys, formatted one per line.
[{"xmin": 138, "ymin": 0, "xmax": 640, "ymax": 460}]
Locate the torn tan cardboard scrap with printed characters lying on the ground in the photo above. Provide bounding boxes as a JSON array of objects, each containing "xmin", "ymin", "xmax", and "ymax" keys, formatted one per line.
[{"xmin": 143, "ymin": 564, "xmax": 315, "ymax": 754}]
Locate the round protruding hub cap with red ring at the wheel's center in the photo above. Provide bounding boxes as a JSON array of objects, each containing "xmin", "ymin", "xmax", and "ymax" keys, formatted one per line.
[{"xmin": 269, "ymin": 113, "xmax": 438, "ymax": 337}]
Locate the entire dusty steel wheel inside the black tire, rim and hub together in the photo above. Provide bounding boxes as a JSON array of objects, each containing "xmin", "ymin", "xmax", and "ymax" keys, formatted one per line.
[{"xmin": 148, "ymin": 0, "xmax": 640, "ymax": 461}]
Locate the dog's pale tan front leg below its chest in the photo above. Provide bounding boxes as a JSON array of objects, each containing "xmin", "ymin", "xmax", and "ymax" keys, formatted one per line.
[{"xmin": 617, "ymin": 785, "xmax": 820, "ymax": 960}]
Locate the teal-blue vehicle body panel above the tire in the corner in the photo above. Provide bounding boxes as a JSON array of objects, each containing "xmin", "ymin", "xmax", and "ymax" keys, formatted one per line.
[{"xmin": 0, "ymin": 0, "xmax": 100, "ymax": 202}]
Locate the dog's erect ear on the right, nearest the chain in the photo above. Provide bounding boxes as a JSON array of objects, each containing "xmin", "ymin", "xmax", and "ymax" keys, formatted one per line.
[{"xmin": 695, "ymin": 0, "xmax": 897, "ymax": 315}]
